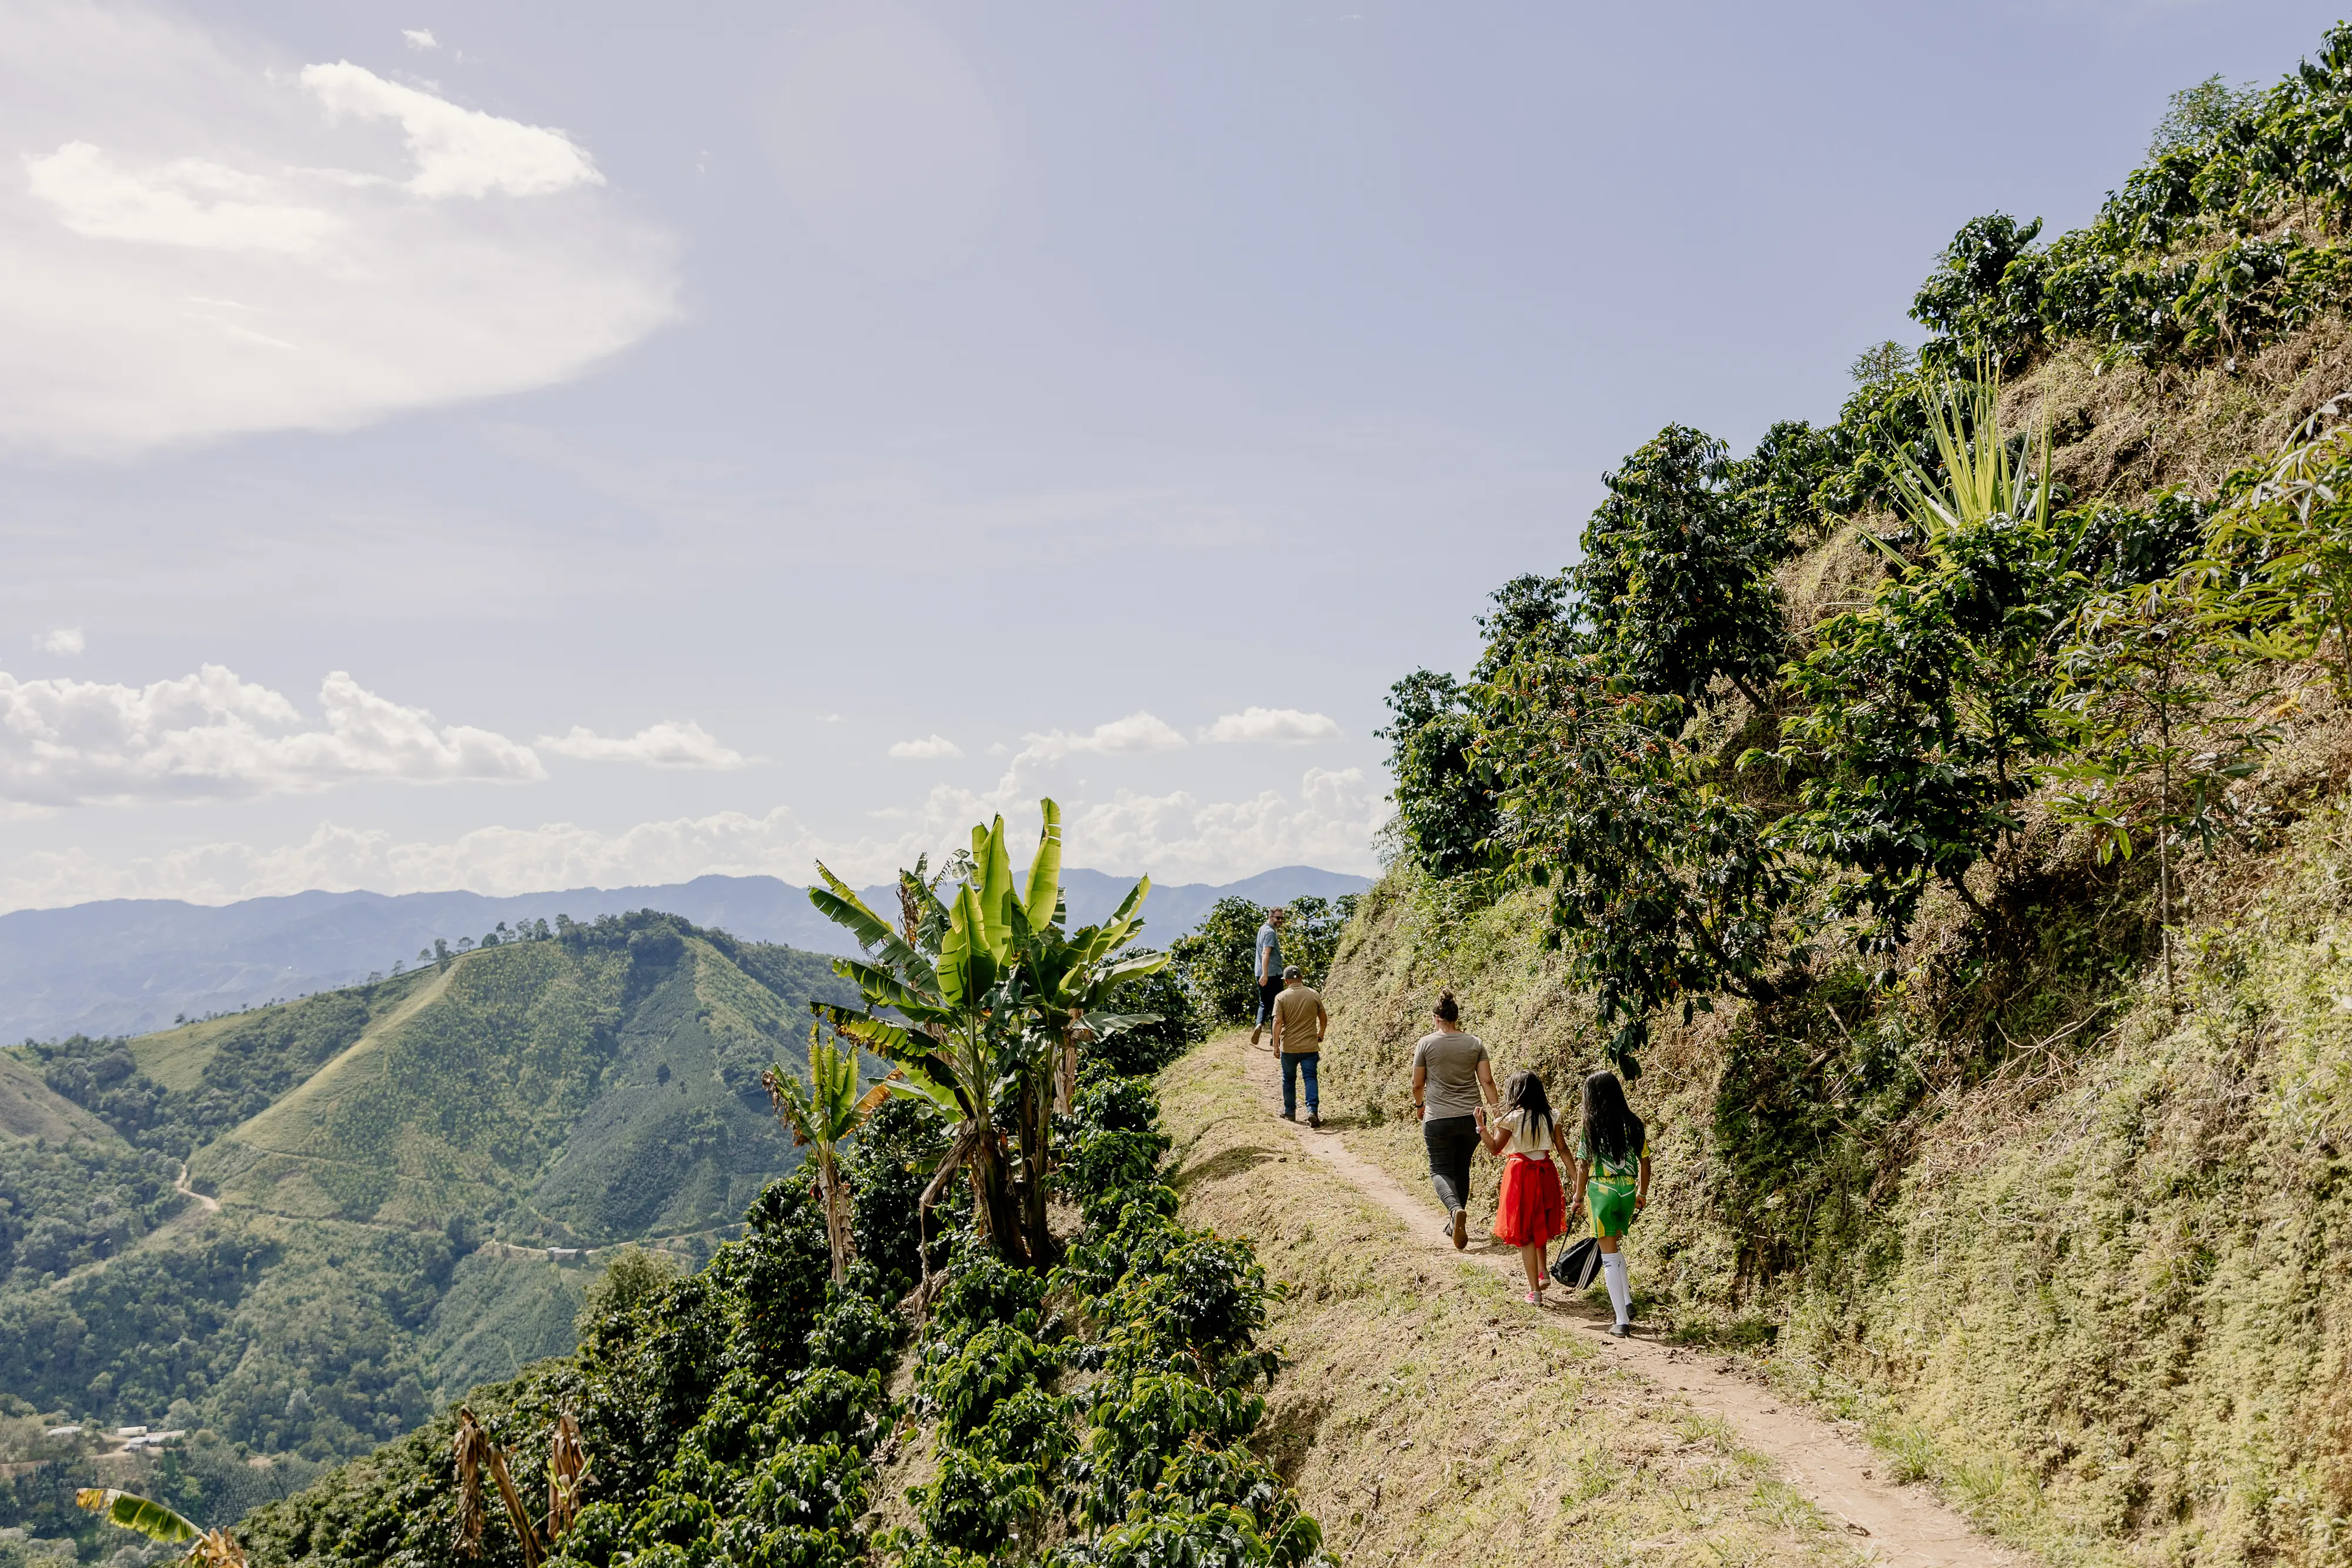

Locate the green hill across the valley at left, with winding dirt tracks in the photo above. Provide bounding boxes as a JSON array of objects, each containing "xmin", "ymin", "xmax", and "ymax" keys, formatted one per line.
[{"xmin": 0, "ymin": 914, "xmax": 842, "ymax": 1476}]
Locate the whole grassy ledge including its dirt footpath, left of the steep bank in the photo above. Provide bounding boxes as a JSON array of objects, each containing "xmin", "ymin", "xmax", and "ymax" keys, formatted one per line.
[{"xmin": 1162, "ymin": 1034, "xmax": 2030, "ymax": 1568}]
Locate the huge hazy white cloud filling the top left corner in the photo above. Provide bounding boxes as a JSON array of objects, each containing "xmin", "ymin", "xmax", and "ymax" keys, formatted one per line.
[{"xmin": 0, "ymin": 0, "xmax": 675, "ymax": 456}]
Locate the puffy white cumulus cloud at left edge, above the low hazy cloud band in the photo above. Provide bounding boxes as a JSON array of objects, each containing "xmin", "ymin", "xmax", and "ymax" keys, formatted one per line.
[{"xmin": 0, "ymin": 666, "xmax": 546, "ymax": 806}]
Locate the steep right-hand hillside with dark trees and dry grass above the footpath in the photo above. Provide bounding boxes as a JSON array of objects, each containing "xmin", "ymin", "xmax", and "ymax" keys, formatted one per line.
[{"xmin": 1322, "ymin": 26, "xmax": 2352, "ymax": 1563}]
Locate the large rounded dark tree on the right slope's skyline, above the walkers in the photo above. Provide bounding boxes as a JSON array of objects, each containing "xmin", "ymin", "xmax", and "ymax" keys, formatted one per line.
[{"xmin": 1571, "ymin": 426, "xmax": 1785, "ymax": 713}]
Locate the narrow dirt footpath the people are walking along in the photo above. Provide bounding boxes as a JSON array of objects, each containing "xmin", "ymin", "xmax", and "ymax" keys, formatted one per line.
[{"xmin": 1204, "ymin": 1034, "xmax": 2032, "ymax": 1568}]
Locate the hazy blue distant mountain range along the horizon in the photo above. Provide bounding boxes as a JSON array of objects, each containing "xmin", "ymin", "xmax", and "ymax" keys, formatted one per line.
[{"xmin": 0, "ymin": 865, "xmax": 1371, "ymax": 1041}]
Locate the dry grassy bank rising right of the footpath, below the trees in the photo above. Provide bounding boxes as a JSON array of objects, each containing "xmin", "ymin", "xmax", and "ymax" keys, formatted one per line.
[{"xmin": 1324, "ymin": 811, "xmax": 2352, "ymax": 1563}]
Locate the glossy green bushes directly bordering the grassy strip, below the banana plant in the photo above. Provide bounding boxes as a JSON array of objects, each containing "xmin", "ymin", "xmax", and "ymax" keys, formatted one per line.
[{"xmin": 898, "ymin": 1076, "xmax": 1322, "ymax": 1566}]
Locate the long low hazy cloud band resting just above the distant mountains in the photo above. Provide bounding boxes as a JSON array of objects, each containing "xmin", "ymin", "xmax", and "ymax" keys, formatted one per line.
[{"xmin": 0, "ymin": 769, "xmax": 1388, "ymax": 910}]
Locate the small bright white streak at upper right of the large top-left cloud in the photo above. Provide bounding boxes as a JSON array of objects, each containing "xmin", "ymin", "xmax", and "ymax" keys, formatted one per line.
[{"xmin": 301, "ymin": 59, "xmax": 604, "ymax": 198}]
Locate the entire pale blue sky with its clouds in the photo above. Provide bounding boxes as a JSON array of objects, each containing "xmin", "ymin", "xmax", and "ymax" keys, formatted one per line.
[{"xmin": 0, "ymin": 0, "xmax": 2333, "ymax": 910}]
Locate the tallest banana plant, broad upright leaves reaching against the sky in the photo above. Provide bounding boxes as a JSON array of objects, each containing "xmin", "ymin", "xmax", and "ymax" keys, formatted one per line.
[{"xmin": 809, "ymin": 799, "xmax": 1167, "ymax": 1286}]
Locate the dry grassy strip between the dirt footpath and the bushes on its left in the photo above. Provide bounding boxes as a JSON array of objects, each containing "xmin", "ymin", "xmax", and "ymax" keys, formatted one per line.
[{"xmin": 1160, "ymin": 1037, "xmax": 1856, "ymax": 1568}]
